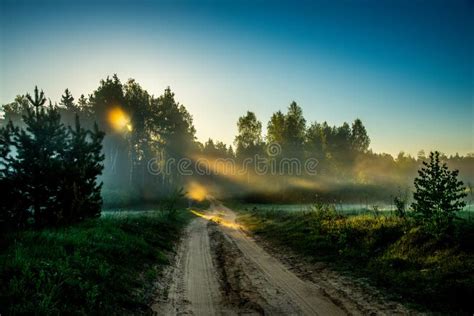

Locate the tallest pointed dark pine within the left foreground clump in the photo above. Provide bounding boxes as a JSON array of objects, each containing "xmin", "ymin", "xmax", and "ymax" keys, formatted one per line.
[{"xmin": 14, "ymin": 87, "xmax": 68, "ymax": 227}]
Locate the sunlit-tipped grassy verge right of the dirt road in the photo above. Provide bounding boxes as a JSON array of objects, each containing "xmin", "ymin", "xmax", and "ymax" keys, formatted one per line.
[{"xmin": 239, "ymin": 208, "xmax": 474, "ymax": 314}]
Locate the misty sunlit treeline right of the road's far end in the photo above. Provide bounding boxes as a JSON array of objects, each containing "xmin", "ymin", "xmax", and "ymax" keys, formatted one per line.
[{"xmin": 220, "ymin": 102, "xmax": 474, "ymax": 204}]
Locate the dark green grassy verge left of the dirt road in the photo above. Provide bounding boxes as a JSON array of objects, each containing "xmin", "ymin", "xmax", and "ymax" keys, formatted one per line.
[{"xmin": 0, "ymin": 211, "xmax": 191, "ymax": 315}]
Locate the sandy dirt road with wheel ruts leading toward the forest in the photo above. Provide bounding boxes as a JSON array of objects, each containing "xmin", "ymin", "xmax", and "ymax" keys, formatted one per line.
[{"xmin": 152, "ymin": 203, "xmax": 408, "ymax": 315}]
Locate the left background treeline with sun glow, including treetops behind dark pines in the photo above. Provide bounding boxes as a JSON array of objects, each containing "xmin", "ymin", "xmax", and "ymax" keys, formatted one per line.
[{"xmin": 3, "ymin": 75, "xmax": 198, "ymax": 205}]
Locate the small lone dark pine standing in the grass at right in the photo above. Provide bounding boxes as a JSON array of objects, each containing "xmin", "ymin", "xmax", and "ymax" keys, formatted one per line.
[{"xmin": 412, "ymin": 151, "xmax": 466, "ymax": 235}]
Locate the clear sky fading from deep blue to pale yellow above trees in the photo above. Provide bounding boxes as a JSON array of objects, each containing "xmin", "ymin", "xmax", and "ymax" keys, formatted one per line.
[{"xmin": 0, "ymin": 0, "xmax": 474, "ymax": 154}]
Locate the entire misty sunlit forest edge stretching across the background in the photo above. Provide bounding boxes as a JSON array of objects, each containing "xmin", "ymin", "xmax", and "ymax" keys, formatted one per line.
[{"xmin": 1, "ymin": 75, "xmax": 474, "ymax": 206}]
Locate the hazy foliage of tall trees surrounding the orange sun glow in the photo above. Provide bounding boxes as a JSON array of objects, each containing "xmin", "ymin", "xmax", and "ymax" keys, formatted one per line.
[{"xmin": 86, "ymin": 75, "xmax": 197, "ymax": 202}]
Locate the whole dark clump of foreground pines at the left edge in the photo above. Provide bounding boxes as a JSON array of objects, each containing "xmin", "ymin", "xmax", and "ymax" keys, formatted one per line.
[{"xmin": 0, "ymin": 88, "xmax": 104, "ymax": 227}]
